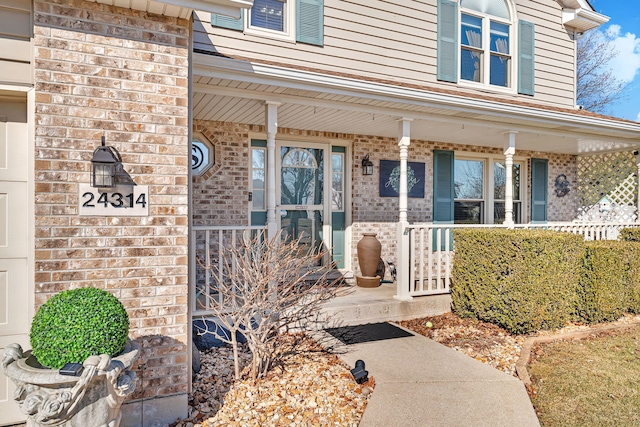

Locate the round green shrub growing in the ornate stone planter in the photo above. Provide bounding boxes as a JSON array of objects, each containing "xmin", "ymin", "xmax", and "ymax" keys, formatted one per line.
[{"xmin": 30, "ymin": 288, "xmax": 129, "ymax": 369}]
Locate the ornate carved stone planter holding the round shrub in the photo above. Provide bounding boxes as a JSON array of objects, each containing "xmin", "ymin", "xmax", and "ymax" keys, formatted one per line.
[{"xmin": 2, "ymin": 340, "xmax": 140, "ymax": 427}]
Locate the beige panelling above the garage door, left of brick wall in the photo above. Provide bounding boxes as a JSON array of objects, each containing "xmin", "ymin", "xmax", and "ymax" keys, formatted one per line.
[{"xmin": 0, "ymin": 0, "xmax": 33, "ymax": 84}]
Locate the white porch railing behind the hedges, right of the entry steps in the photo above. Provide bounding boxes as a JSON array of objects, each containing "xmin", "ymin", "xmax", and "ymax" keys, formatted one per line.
[{"xmin": 396, "ymin": 222, "xmax": 640, "ymax": 299}]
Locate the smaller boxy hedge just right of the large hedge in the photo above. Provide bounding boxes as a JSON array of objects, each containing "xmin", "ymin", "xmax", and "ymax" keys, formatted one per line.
[{"xmin": 577, "ymin": 241, "xmax": 628, "ymax": 323}]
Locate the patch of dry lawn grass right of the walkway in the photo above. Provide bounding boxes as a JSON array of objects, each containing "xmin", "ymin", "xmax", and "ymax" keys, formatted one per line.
[{"xmin": 529, "ymin": 327, "xmax": 640, "ymax": 427}]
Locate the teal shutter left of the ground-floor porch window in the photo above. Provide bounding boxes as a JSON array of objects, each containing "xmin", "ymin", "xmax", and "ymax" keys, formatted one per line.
[{"xmin": 433, "ymin": 150, "xmax": 454, "ymax": 224}]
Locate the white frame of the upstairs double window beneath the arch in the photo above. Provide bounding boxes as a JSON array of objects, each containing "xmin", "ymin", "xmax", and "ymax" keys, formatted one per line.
[{"xmin": 458, "ymin": 2, "xmax": 518, "ymax": 94}]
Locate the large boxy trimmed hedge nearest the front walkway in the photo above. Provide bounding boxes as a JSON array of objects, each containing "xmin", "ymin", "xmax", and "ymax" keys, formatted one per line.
[{"xmin": 451, "ymin": 228, "xmax": 584, "ymax": 334}]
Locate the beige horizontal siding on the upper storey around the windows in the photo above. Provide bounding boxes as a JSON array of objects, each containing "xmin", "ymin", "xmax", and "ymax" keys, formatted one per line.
[{"xmin": 194, "ymin": 0, "xmax": 575, "ymax": 107}]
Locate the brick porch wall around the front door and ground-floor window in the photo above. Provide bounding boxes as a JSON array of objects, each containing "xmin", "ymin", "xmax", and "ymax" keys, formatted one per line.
[{"xmin": 192, "ymin": 121, "xmax": 578, "ymax": 274}]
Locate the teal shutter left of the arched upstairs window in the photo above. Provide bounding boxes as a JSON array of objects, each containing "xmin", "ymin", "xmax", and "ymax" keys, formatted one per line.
[{"xmin": 437, "ymin": 0, "xmax": 458, "ymax": 83}]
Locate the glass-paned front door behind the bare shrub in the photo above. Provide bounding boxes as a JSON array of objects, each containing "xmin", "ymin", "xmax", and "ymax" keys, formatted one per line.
[{"xmin": 276, "ymin": 142, "xmax": 331, "ymax": 258}]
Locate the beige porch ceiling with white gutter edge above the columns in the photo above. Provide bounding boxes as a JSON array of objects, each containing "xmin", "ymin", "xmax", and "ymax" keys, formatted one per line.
[{"xmin": 193, "ymin": 54, "xmax": 640, "ymax": 154}]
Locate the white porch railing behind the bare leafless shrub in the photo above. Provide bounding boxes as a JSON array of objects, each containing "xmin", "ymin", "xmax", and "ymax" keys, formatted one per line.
[{"xmin": 190, "ymin": 225, "xmax": 266, "ymax": 315}]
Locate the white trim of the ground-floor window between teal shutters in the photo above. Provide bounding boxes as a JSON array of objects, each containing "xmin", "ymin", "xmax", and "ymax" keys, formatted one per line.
[{"xmin": 453, "ymin": 151, "xmax": 529, "ymax": 224}]
